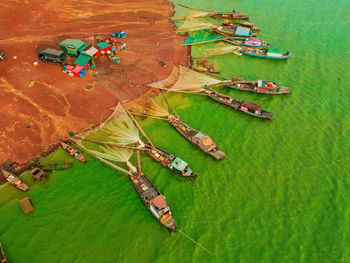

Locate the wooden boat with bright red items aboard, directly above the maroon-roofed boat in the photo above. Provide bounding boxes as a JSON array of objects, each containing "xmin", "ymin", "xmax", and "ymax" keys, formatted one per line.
[{"xmin": 227, "ymin": 80, "xmax": 290, "ymax": 95}]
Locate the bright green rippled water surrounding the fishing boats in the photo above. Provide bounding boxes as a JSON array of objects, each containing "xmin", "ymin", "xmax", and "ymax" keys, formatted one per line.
[{"xmin": 0, "ymin": 0, "xmax": 350, "ymax": 263}]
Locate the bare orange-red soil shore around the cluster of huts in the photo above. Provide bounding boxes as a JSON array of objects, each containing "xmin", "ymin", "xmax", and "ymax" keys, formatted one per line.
[{"xmin": 0, "ymin": 0, "xmax": 186, "ymax": 163}]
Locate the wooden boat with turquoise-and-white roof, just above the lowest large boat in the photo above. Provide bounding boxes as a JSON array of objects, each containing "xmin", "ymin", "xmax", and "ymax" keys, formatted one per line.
[{"xmin": 145, "ymin": 145, "xmax": 198, "ymax": 179}]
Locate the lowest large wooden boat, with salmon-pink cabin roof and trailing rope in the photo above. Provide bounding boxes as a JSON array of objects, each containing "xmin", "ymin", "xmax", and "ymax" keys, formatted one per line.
[{"xmin": 130, "ymin": 171, "xmax": 177, "ymax": 232}]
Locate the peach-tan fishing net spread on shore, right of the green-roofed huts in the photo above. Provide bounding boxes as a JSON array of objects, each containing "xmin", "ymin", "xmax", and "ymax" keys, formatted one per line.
[{"xmin": 148, "ymin": 65, "xmax": 222, "ymax": 93}]
